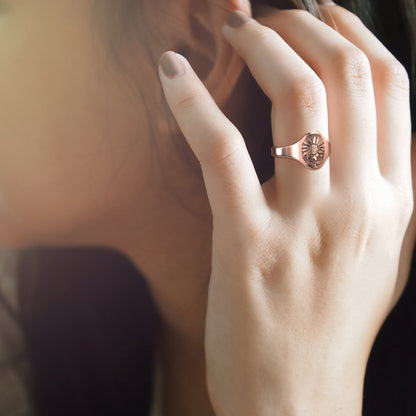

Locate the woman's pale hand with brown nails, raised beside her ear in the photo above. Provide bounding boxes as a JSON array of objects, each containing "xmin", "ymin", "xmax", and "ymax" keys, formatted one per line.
[{"xmin": 156, "ymin": 1, "xmax": 413, "ymax": 416}]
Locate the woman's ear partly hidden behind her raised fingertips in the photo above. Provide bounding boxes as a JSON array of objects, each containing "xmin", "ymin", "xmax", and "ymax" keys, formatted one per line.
[{"xmin": 176, "ymin": 0, "xmax": 252, "ymax": 107}]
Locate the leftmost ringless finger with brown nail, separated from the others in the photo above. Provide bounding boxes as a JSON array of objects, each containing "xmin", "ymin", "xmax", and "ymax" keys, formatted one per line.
[{"xmin": 159, "ymin": 51, "xmax": 267, "ymax": 228}]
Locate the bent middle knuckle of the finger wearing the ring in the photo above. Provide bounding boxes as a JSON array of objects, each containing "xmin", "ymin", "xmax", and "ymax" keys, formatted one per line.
[{"xmin": 281, "ymin": 74, "xmax": 326, "ymax": 109}]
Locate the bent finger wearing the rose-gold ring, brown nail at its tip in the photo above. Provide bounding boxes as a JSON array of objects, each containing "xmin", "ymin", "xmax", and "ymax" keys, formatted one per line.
[{"xmin": 224, "ymin": 12, "xmax": 330, "ymax": 210}]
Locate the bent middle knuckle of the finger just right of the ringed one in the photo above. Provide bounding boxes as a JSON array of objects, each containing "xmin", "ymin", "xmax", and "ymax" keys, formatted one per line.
[{"xmin": 334, "ymin": 46, "xmax": 371, "ymax": 89}]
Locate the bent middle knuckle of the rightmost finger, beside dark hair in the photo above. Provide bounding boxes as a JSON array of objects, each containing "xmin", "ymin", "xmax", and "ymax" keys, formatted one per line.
[{"xmin": 374, "ymin": 58, "xmax": 410, "ymax": 94}]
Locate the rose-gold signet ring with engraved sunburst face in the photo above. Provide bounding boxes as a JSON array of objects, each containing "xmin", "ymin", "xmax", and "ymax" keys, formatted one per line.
[{"xmin": 271, "ymin": 131, "xmax": 331, "ymax": 170}]
